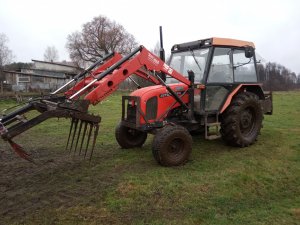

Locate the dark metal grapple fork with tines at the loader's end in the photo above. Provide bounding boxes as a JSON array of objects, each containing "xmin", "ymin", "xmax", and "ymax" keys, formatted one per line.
[{"xmin": 0, "ymin": 96, "xmax": 101, "ymax": 161}]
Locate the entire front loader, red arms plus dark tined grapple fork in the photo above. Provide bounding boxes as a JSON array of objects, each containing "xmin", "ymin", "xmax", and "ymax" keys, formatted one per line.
[{"xmin": 0, "ymin": 46, "xmax": 191, "ymax": 161}]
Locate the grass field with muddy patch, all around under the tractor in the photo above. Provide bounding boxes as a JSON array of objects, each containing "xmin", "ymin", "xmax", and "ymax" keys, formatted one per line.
[{"xmin": 0, "ymin": 92, "xmax": 300, "ymax": 225}]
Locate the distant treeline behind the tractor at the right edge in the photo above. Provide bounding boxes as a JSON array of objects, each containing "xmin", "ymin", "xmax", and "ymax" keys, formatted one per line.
[{"xmin": 257, "ymin": 62, "xmax": 300, "ymax": 91}]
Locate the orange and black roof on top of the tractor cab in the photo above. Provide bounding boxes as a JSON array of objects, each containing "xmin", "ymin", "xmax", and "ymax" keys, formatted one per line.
[{"xmin": 171, "ymin": 37, "xmax": 255, "ymax": 52}]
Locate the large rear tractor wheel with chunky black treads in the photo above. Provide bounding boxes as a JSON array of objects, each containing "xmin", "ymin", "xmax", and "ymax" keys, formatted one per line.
[{"xmin": 221, "ymin": 92, "xmax": 263, "ymax": 147}]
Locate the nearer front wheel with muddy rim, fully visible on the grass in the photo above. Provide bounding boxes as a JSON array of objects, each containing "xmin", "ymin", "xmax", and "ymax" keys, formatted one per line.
[{"xmin": 152, "ymin": 125, "xmax": 192, "ymax": 166}]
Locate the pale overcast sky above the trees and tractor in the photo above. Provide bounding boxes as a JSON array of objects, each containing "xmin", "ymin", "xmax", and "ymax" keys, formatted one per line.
[{"xmin": 0, "ymin": 0, "xmax": 300, "ymax": 74}]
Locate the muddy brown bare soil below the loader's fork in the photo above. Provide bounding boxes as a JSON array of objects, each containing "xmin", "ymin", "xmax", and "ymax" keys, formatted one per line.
[{"xmin": 0, "ymin": 142, "xmax": 119, "ymax": 224}]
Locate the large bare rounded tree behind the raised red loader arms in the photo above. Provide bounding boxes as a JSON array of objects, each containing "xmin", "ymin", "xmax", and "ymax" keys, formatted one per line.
[{"xmin": 66, "ymin": 16, "xmax": 137, "ymax": 65}]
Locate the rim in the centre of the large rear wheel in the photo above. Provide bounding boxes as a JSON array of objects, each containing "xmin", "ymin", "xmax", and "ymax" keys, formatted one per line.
[{"xmin": 240, "ymin": 107, "xmax": 256, "ymax": 136}]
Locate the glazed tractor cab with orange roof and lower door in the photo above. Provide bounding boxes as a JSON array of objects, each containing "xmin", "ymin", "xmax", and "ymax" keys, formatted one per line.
[{"xmin": 167, "ymin": 38, "xmax": 263, "ymax": 114}]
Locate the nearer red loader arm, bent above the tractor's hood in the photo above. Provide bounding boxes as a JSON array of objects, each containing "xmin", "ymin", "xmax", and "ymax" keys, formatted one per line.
[{"xmin": 69, "ymin": 46, "xmax": 190, "ymax": 105}]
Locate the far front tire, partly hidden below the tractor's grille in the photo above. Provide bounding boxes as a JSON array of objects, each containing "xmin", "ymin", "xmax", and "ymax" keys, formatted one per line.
[{"xmin": 115, "ymin": 122, "xmax": 147, "ymax": 149}]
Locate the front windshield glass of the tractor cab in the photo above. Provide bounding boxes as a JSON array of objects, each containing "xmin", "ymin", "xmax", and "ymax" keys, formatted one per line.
[{"xmin": 167, "ymin": 48, "xmax": 209, "ymax": 84}]
